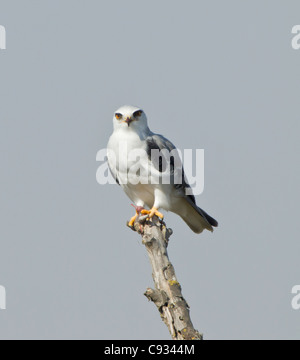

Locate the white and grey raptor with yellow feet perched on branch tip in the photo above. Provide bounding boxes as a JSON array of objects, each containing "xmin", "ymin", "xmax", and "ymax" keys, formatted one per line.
[{"xmin": 107, "ymin": 105, "xmax": 218, "ymax": 234}]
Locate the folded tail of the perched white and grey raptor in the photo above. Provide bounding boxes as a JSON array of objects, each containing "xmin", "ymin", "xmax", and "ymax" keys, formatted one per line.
[{"xmin": 178, "ymin": 198, "xmax": 218, "ymax": 234}]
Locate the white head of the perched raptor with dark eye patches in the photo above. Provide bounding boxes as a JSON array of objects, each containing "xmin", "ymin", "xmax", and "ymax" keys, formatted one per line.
[{"xmin": 113, "ymin": 105, "xmax": 149, "ymax": 133}]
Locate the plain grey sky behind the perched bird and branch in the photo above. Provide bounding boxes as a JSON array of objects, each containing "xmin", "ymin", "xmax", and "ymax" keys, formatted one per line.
[{"xmin": 0, "ymin": 0, "xmax": 300, "ymax": 339}]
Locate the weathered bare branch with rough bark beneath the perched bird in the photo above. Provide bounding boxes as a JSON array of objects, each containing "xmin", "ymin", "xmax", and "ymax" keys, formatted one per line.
[{"xmin": 127, "ymin": 216, "xmax": 203, "ymax": 340}]
